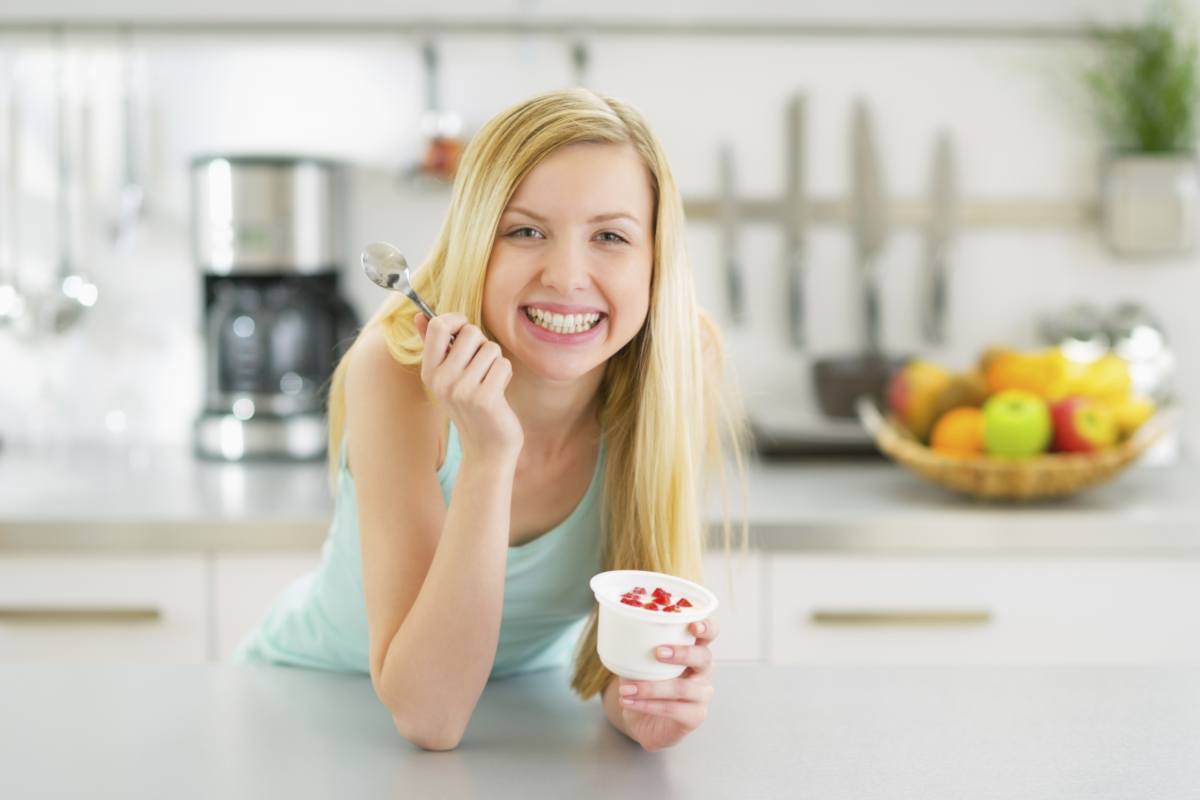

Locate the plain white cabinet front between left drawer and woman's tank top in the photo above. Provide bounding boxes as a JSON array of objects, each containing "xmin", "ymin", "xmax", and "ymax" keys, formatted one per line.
[{"xmin": 212, "ymin": 552, "xmax": 320, "ymax": 661}]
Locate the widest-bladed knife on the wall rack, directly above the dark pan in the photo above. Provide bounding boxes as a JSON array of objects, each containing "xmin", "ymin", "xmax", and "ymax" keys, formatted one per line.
[{"xmin": 851, "ymin": 100, "xmax": 888, "ymax": 355}]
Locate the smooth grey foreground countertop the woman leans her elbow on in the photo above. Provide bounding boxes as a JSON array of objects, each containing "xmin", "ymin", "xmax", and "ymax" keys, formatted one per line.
[{"xmin": 0, "ymin": 664, "xmax": 1200, "ymax": 800}]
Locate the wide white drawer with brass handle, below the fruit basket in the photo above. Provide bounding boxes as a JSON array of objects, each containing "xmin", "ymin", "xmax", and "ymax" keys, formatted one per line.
[{"xmin": 769, "ymin": 555, "xmax": 1200, "ymax": 664}]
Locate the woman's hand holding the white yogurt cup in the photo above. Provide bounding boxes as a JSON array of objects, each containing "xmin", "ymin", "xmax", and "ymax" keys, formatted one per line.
[{"xmin": 617, "ymin": 619, "xmax": 716, "ymax": 752}]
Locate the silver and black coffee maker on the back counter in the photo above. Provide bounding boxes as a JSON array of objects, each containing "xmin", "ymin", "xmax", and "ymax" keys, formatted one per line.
[{"xmin": 191, "ymin": 155, "xmax": 358, "ymax": 461}]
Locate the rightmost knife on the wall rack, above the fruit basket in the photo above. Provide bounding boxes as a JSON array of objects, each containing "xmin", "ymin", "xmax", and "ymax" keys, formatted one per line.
[{"xmin": 920, "ymin": 132, "xmax": 958, "ymax": 345}]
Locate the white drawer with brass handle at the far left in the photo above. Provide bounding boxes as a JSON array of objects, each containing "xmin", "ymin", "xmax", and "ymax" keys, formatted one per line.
[{"xmin": 0, "ymin": 555, "xmax": 208, "ymax": 663}]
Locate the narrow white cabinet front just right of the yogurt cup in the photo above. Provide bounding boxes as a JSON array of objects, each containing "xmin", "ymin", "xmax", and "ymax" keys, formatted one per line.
[{"xmin": 704, "ymin": 548, "xmax": 766, "ymax": 661}]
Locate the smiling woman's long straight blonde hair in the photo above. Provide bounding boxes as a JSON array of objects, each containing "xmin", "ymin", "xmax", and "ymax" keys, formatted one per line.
[{"xmin": 329, "ymin": 88, "xmax": 748, "ymax": 699}]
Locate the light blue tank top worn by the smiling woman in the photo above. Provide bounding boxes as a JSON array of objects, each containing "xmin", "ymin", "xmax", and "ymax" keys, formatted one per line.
[{"xmin": 234, "ymin": 422, "xmax": 605, "ymax": 678}]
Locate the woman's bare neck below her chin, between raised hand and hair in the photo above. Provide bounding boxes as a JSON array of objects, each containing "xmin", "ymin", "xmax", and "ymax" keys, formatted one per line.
[{"xmin": 505, "ymin": 366, "xmax": 604, "ymax": 463}]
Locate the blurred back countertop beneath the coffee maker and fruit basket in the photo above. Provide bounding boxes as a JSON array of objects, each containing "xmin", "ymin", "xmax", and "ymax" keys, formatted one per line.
[{"xmin": 0, "ymin": 449, "xmax": 1200, "ymax": 557}]
